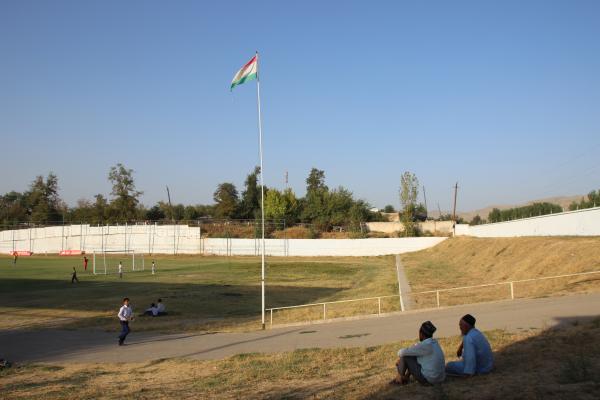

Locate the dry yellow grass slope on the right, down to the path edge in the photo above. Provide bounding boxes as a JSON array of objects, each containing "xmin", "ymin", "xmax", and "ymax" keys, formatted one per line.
[{"xmin": 402, "ymin": 237, "xmax": 600, "ymax": 307}]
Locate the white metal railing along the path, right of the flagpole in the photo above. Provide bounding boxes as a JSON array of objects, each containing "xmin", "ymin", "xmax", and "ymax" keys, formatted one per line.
[{"xmin": 266, "ymin": 271, "xmax": 600, "ymax": 327}]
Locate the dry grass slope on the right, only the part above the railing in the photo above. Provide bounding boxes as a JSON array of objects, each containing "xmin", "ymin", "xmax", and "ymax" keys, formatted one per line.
[{"xmin": 402, "ymin": 237, "xmax": 600, "ymax": 292}]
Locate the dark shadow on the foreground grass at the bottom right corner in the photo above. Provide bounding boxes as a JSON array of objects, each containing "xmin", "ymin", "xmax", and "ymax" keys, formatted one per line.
[{"xmin": 352, "ymin": 316, "xmax": 600, "ymax": 400}]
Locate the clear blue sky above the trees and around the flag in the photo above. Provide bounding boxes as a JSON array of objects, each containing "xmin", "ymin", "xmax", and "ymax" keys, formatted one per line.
[{"xmin": 0, "ymin": 0, "xmax": 600, "ymax": 210}]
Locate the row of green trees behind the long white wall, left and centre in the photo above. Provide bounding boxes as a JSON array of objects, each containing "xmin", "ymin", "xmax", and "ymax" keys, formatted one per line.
[{"xmin": 0, "ymin": 164, "xmax": 383, "ymax": 231}]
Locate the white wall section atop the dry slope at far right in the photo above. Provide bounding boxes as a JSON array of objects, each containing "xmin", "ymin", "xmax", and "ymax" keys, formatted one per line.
[{"xmin": 456, "ymin": 207, "xmax": 600, "ymax": 237}]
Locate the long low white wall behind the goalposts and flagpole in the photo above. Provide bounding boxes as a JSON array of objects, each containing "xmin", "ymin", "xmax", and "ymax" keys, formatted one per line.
[{"xmin": 0, "ymin": 225, "xmax": 444, "ymax": 256}]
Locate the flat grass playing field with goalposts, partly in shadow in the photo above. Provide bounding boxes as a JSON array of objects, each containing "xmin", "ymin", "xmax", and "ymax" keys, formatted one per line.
[{"xmin": 0, "ymin": 256, "xmax": 396, "ymax": 332}]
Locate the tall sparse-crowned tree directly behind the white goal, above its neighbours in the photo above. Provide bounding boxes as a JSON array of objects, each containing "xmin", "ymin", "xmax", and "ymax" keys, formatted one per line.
[{"xmin": 108, "ymin": 163, "xmax": 143, "ymax": 221}]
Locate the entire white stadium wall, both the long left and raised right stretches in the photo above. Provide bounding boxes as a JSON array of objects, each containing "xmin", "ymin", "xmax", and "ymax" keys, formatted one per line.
[{"xmin": 0, "ymin": 207, "xmax": 600, "ymax": 256}]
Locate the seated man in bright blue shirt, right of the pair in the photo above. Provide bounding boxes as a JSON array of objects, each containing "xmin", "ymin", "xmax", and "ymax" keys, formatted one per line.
[{"xmin": 446, "ymin": 314, "xmax": 494, "ymax": 377}]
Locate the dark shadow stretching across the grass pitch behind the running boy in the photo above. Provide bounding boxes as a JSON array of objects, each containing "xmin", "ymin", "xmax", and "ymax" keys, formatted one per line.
[{"xmin": 0, "ymin": 279, "xmax": 341, "ymax": 332}]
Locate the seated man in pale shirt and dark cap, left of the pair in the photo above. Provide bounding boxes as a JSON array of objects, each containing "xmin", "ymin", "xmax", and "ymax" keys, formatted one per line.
[{"xmin": 390, "ymin": 321, "xmax": 446, "ymax": 385}]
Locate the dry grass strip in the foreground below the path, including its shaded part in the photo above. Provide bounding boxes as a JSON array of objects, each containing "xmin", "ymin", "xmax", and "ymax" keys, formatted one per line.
[{"xmin": 0, "ymin": 318, "xmax": 600, "ymax": 399}]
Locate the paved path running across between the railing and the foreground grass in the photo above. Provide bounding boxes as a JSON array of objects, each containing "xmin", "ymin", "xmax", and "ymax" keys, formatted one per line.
[{"xmin": 0, "ymin": 294, "xmax": 600, "ymax": 363}]
